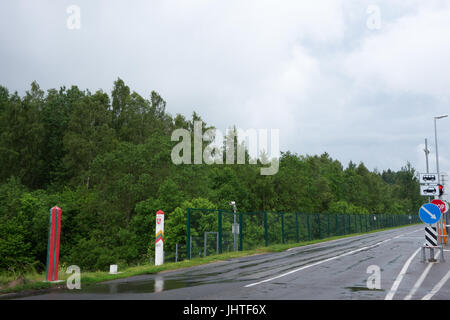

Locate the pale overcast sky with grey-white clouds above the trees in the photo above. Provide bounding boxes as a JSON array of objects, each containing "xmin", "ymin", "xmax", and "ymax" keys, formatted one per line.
[{"xmin": 0, "ymin": 0, "xmax": 450, "ymax": 172}]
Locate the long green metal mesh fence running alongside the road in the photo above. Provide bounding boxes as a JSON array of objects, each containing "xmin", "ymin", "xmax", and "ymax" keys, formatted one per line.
[{"xmin": 185, "ymin": 208, "xmax": 420, "ymax": 259}]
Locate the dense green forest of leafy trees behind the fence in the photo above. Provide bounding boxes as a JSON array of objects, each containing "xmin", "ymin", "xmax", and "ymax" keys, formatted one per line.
[{"xmin": 0, "ymin": 79, "xmax": 423, "ymax": 271}]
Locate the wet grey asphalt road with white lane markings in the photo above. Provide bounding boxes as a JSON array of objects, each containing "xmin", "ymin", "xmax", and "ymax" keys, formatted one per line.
[{"xmin": 13, "ymin": 225, "xmax": 450, "ymax": 300}]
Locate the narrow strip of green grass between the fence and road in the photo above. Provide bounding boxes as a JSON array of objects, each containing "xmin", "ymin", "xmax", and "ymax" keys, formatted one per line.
[{"xmin": 0, "ymin": 224, "xmax": 422, "ymax": 294}]
